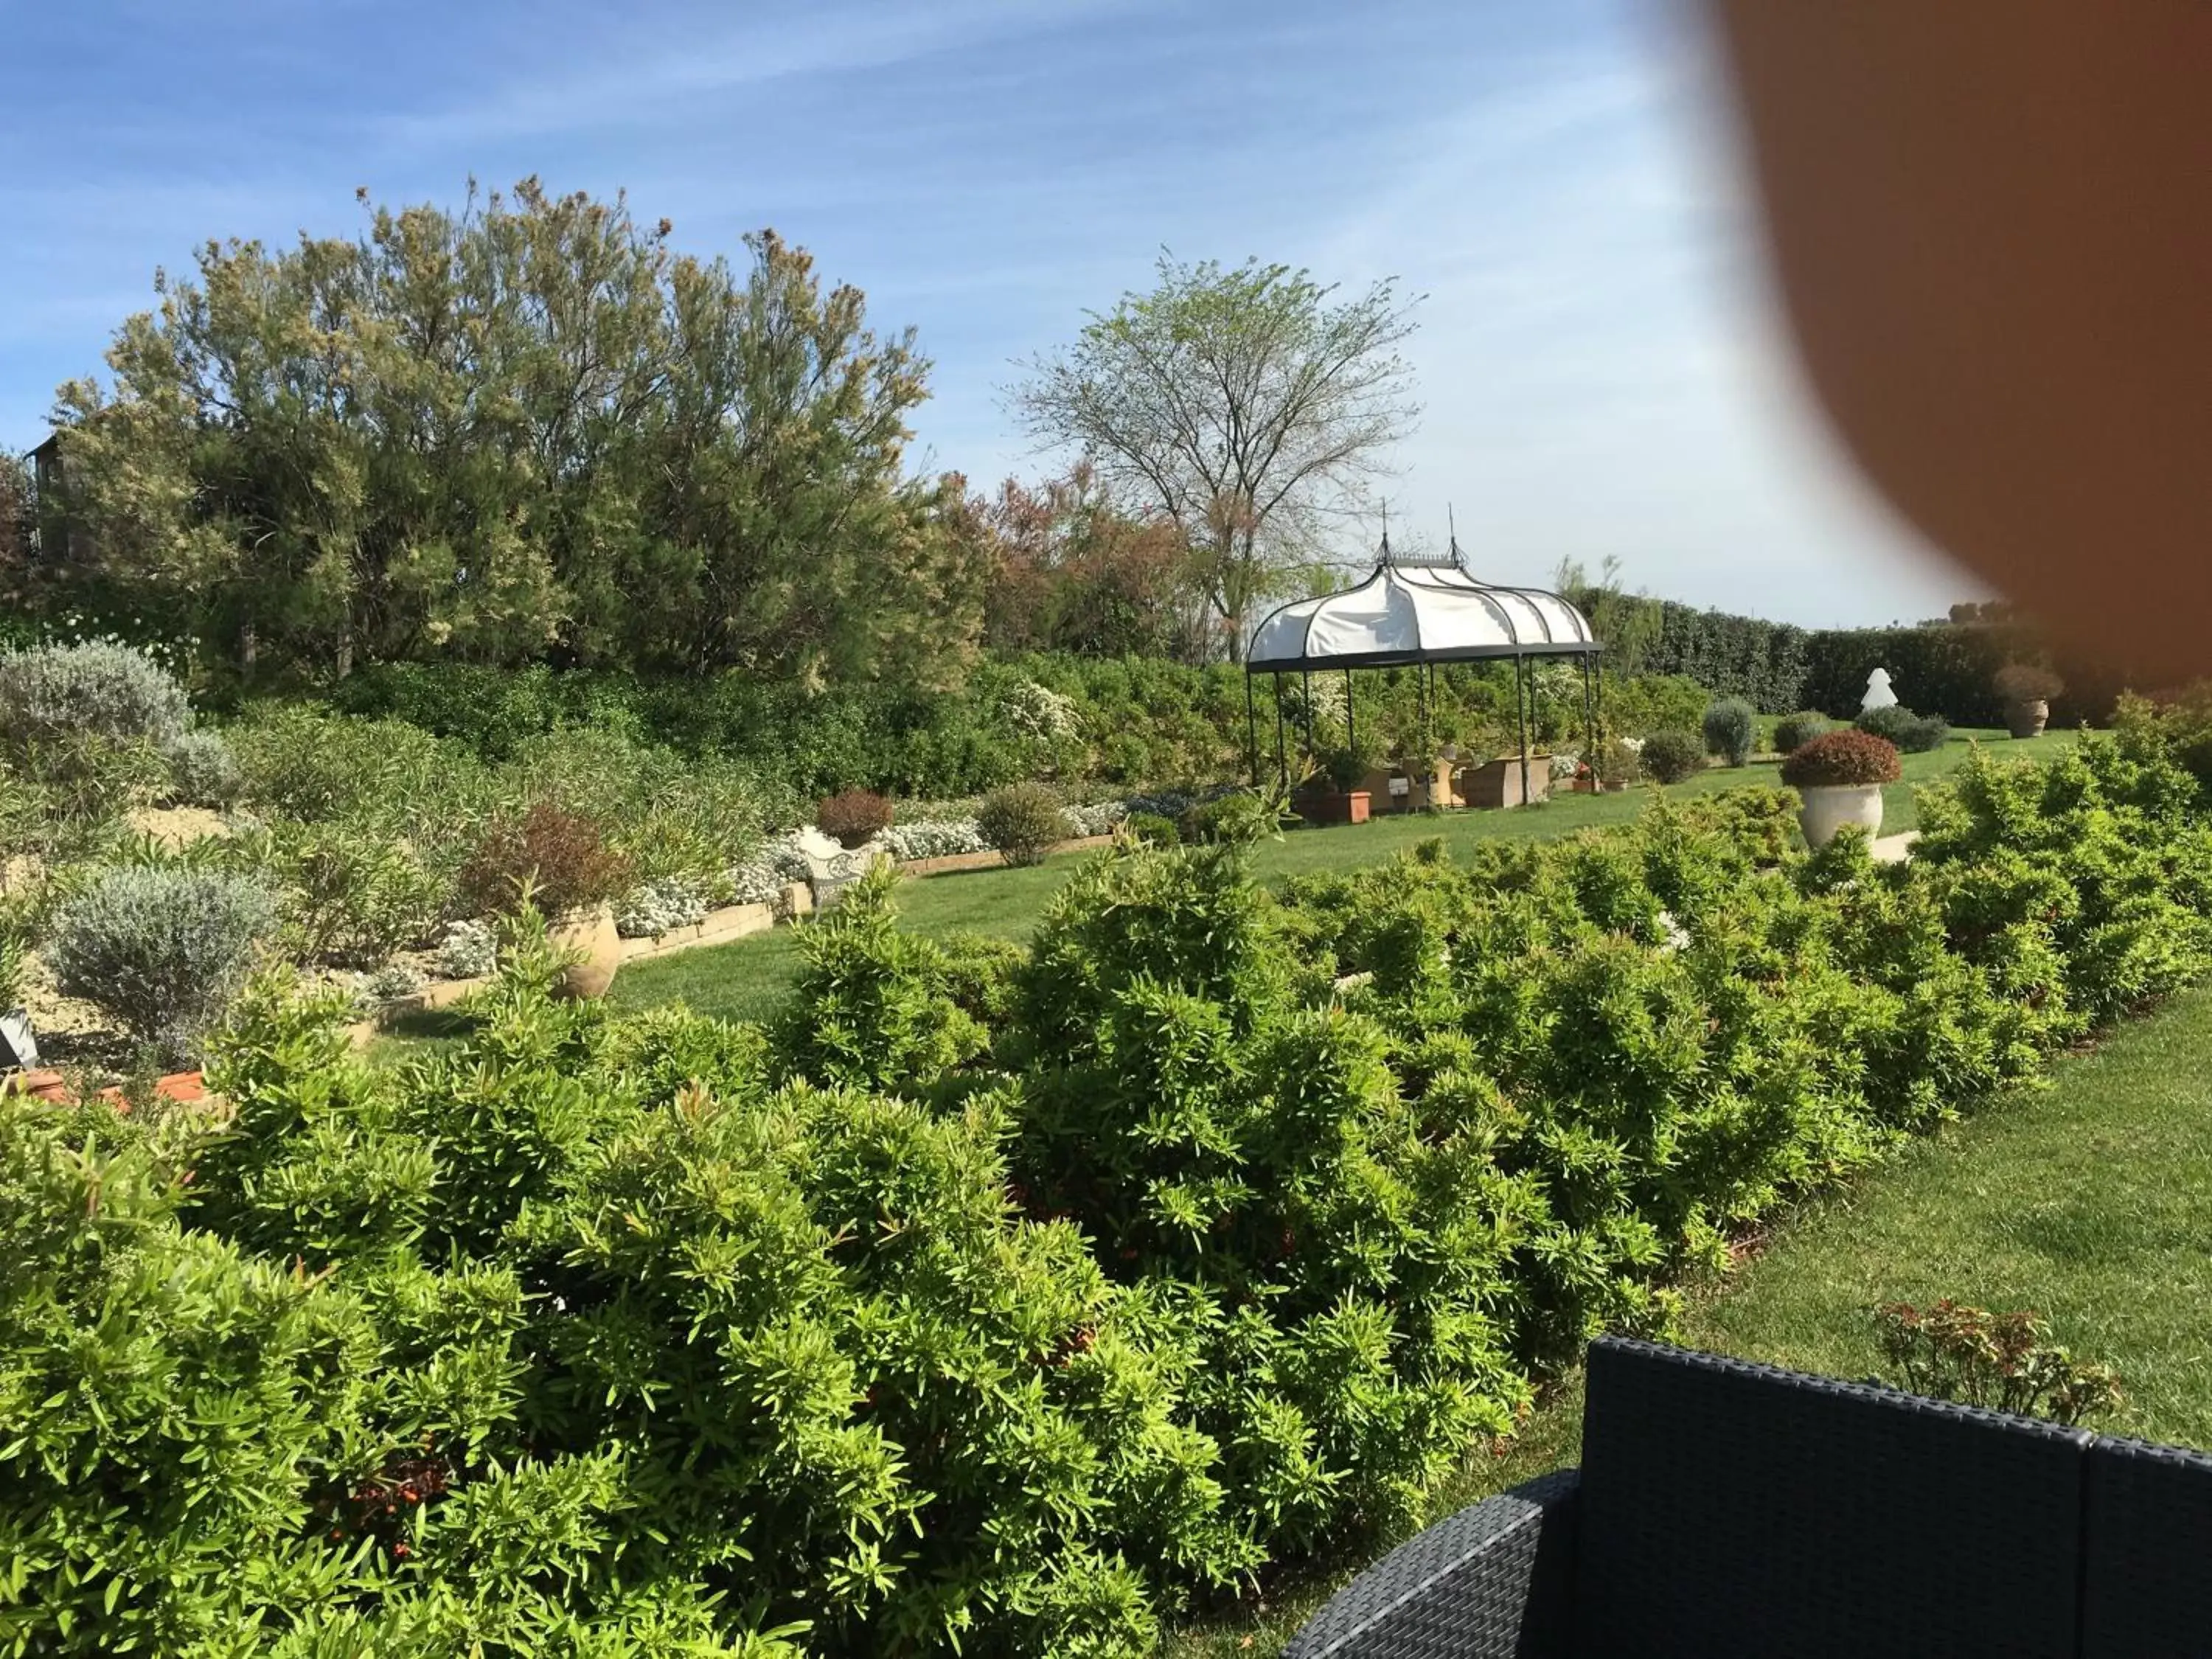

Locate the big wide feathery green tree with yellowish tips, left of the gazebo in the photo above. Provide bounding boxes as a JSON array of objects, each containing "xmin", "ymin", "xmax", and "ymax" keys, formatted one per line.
[{"xmin": 43, "ymin": 179, "xmax": 984, "ymax": 679}]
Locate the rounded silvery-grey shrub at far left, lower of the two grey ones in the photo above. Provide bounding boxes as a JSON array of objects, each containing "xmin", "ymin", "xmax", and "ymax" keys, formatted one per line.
[{"xmin": 46, "ymin": 867, "xmax": 276, "ymax": 1060}]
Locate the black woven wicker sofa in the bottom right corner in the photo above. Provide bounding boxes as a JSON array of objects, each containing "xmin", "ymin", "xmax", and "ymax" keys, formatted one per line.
[{"xmin": 1285, "ymin": 1338, "xmax": 2212, "ymax": 1659}]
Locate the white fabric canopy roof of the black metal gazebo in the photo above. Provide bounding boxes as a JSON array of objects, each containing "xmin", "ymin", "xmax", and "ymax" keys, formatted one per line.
[{"xmin": 1245, "ymin": 538, "xmax": 1599, "ymax": 675}]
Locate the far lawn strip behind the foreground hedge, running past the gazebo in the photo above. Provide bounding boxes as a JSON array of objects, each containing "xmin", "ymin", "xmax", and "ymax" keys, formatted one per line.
[{"xmin": 613, "ymin": 732, "xmax": 2073, "ymax": 1035}]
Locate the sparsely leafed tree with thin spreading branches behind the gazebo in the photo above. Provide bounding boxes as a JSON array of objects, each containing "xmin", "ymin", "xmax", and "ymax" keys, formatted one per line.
[{"xmin": 1013, "ymin": 254, "xmax": 1420, "ymax": 655}]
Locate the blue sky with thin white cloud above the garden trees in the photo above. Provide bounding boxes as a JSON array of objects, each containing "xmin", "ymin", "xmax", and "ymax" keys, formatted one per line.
[{"xmin": 0, "ymin": 0, "xmax": 1975, "ymax": 624}]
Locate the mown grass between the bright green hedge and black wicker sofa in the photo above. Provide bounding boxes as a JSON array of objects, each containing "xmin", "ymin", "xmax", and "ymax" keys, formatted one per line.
[{"xmin": 1170, "ymin": 991, "xmax": 2212, "ymax": 1659}]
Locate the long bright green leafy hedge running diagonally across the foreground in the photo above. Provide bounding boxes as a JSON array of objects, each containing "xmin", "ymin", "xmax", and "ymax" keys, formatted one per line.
[{"xmin": 0, "ymin": 726, "xmax": 2212, "ymax": 1659}]
